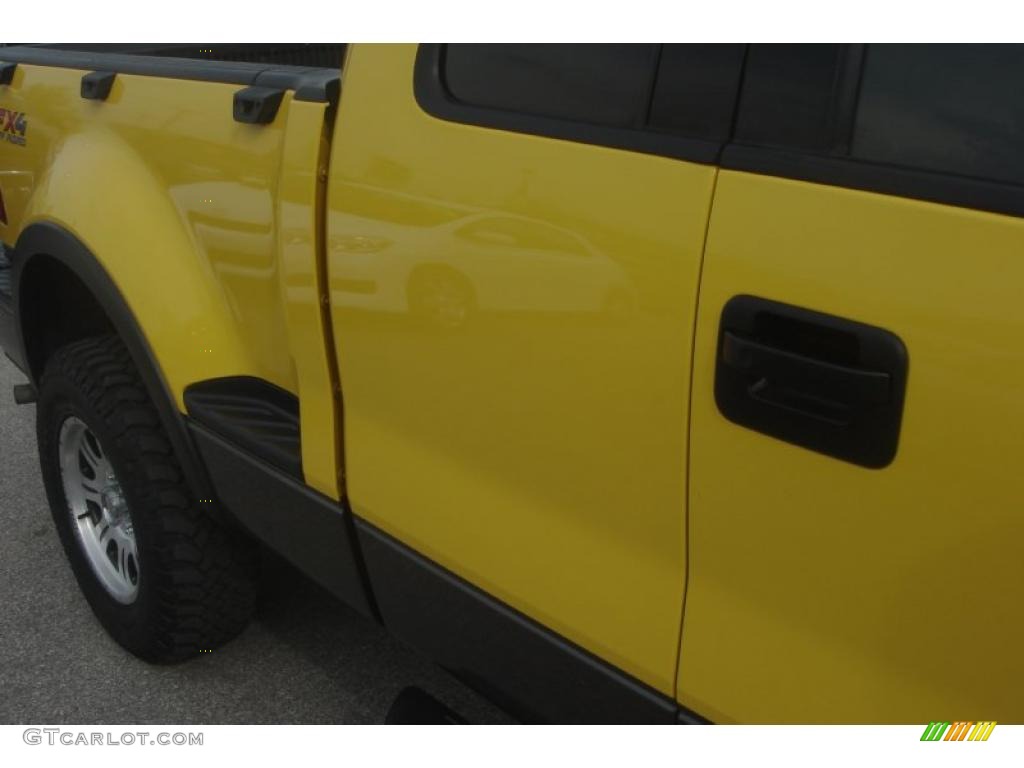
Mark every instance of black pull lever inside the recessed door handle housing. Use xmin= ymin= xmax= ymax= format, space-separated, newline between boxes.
xmin=722 ymin=331 xmax=892 ymax=425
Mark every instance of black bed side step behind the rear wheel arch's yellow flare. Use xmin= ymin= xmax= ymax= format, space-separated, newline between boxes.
xmin=184 ymin=376 xmax=302 ymax=480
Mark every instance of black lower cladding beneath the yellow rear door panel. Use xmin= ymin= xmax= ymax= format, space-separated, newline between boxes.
xmin=353 ymin=515 xmax=702 ymax=724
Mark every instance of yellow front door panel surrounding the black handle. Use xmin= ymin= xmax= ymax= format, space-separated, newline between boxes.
xmin=678 ymin=171 xmax=1024 ymax=723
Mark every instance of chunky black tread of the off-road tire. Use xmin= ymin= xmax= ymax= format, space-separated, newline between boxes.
xmin=42 ymin=336 xmax=256 ymax=663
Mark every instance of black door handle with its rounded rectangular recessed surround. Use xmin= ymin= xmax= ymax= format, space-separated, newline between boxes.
xmin=715 ymin=296 xmax=907 ymax=467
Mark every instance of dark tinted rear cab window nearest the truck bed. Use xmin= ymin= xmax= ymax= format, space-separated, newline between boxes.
xmin=444 ymin=44 xmax=657 ymax=127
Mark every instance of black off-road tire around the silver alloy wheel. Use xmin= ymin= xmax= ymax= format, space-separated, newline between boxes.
xmin=36 ymin=336 xmax=256 ymax=663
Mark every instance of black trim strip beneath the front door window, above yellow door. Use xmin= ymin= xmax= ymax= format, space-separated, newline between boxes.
xmin=721 ymin=144 xmax=1024 ymax=221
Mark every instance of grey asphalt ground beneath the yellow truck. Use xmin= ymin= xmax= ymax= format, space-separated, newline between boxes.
xmin=0 ymin=354 xmax=506 ymax=724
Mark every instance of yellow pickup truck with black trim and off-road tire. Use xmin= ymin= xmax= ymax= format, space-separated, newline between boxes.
xmin=0 ymin=44 xmax=1024 ymax=723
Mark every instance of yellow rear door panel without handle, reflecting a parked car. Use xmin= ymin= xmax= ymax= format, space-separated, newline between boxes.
xmin=328 ymin=46 xmax=715 ymax=695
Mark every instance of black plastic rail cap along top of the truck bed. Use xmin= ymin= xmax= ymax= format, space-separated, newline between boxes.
xmin=3 ymin=46 xmax=340 ymax=103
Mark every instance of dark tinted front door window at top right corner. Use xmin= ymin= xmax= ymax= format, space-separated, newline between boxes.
xmin=852 ymin=45 xmax=1024 ymax=183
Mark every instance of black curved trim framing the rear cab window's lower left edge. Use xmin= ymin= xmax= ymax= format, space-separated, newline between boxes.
xmin=414 ymin=43 xmax=722 ymax=165
